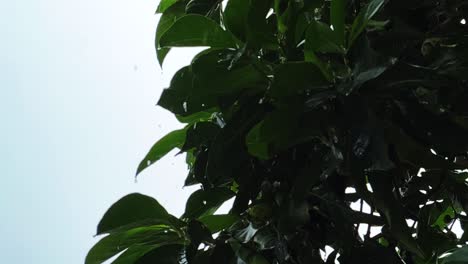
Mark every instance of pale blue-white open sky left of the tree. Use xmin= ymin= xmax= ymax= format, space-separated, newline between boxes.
xmin=0 ymin=0 xmax=194 ymax=264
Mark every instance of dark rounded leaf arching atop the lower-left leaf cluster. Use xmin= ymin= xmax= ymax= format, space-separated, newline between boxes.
xmin=97 ymin=193 xmax=173 ymax=235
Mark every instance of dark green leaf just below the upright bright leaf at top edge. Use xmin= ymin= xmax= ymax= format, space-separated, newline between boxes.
xmin=304 ymin=21 xmax=346 ymax=54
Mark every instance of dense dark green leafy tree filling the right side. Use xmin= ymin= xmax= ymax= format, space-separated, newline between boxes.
xmin=86 ymin=0 xmax=468 ymax=264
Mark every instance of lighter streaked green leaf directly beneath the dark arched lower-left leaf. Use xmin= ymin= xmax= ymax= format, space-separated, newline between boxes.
xmin=85 ymin=225 xmax=185 ymax=264
